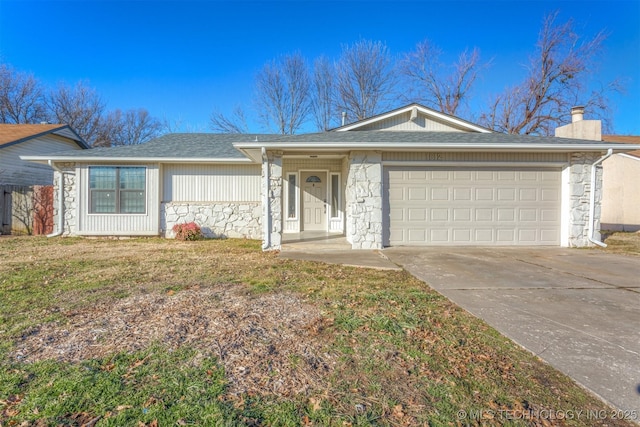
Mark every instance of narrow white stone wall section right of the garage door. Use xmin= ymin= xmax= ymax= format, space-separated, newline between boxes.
xmin=569 ymin=153 xmax=602 ymax=247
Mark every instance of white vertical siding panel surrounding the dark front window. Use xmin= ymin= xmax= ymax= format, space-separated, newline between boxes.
xmin=76 ymin=164 xmax=160 ymax=236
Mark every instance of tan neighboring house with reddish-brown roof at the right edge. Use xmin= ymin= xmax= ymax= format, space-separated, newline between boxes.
xmin=602 ymin=135 xmax=640 ymax=231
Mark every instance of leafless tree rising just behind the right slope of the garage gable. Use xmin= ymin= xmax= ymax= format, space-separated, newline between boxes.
xmin=399 ymin=40 xmax=486 ymax=115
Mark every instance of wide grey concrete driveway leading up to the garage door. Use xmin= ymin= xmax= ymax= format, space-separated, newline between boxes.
xmin=384 ymin=247 xmax=640 ymax=414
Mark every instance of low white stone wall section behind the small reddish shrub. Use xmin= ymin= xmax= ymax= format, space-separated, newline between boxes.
xmin=160 ymin=202 xmax=262 ymax=239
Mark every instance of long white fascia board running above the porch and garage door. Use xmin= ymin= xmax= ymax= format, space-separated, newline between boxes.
xmin=235 ymin=142 xmax=640 ymax=154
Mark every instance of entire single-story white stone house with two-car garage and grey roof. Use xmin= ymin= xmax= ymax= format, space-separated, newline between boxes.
xmin=23 ymin=104 xmax=640 ymax=250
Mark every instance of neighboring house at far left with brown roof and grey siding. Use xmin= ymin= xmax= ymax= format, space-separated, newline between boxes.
xmin=0 ymin=124 xmax=89 ymax=185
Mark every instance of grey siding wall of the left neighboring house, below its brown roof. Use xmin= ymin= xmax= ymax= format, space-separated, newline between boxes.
xmin=0 ymin=135 xmax=82 ymax=185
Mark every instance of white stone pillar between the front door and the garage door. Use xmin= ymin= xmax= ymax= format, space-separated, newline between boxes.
xmin=346 ymin=151 xmax=382 ymax=249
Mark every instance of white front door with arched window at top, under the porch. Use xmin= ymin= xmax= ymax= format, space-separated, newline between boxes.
xmin=301 ymin=172 xmax=327 ymax=231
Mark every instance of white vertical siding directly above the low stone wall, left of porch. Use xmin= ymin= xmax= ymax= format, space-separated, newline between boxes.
xmin=162 ymin=164 xmax=261 ymax=202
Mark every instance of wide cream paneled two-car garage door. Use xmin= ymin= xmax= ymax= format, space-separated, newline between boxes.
xmin=385 ymin=168 xmax=561 ymax=246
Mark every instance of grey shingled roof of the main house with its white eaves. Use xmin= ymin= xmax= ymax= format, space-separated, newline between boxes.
xmin=18 ymin=131 xmax=640 ymax=163
